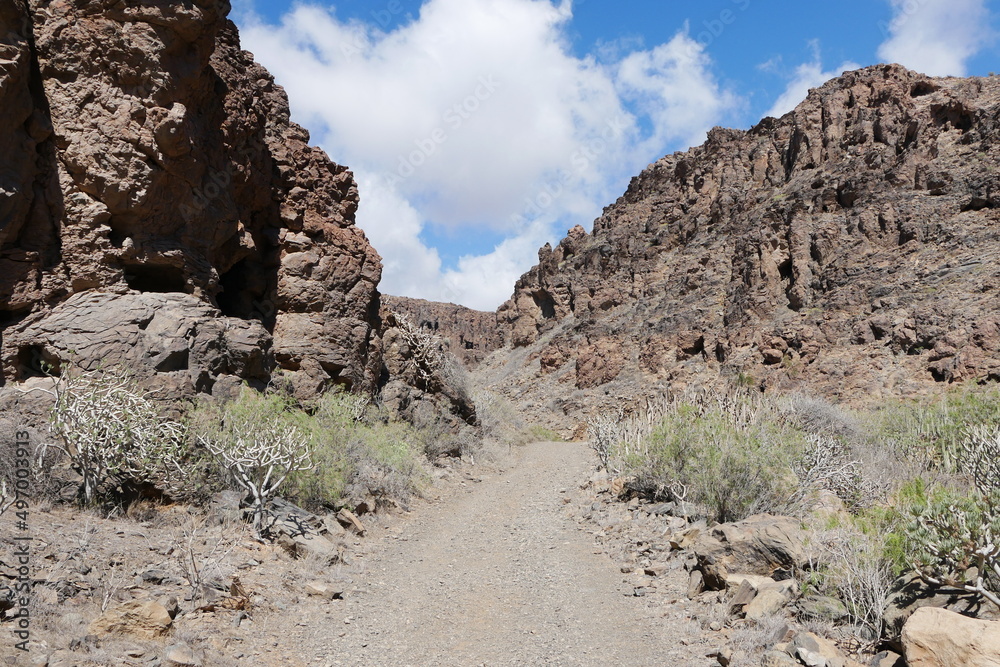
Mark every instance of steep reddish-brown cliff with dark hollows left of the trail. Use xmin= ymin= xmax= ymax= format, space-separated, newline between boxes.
xmin=0 ymin=0 xmax=381 ymax=394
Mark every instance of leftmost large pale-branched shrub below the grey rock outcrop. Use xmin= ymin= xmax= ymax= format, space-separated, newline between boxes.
xmin=38 ymin=364 xmax=185 ymax=504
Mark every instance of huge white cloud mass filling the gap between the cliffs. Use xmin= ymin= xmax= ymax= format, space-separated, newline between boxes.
xmin=234 ymin=0 xmax=735 ymax=309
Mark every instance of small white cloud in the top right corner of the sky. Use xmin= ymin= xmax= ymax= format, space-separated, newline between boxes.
xmin=878 ymin=0 xmax=992 ymax=76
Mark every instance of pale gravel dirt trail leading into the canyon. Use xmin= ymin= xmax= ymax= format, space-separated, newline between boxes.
xmin=315 ymin=443 xmax=714 ymax=667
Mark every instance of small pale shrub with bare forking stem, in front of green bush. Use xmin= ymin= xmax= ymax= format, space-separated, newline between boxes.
xmin=189 ymin=387 xmax=313 ymax=538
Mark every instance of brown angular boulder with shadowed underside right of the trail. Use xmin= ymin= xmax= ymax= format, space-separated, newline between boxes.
xmin=691 ymin=514 xmax=806 ymax=590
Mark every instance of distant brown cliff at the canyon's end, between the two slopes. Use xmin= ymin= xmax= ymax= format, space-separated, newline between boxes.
xmin=382 ymin=295 xmax=503 ymax=368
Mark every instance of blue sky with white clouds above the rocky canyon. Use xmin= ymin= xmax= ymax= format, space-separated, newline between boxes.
xmin=232 ymin=0 xmax=1000 ymax=310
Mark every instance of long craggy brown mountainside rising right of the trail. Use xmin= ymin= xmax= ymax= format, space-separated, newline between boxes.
xmin=498 ymin=65 xmax=1000 ymax=426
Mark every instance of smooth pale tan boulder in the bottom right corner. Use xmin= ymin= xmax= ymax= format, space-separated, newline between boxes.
xmin=902 ymin=607 xmax=1000 ymax=667
